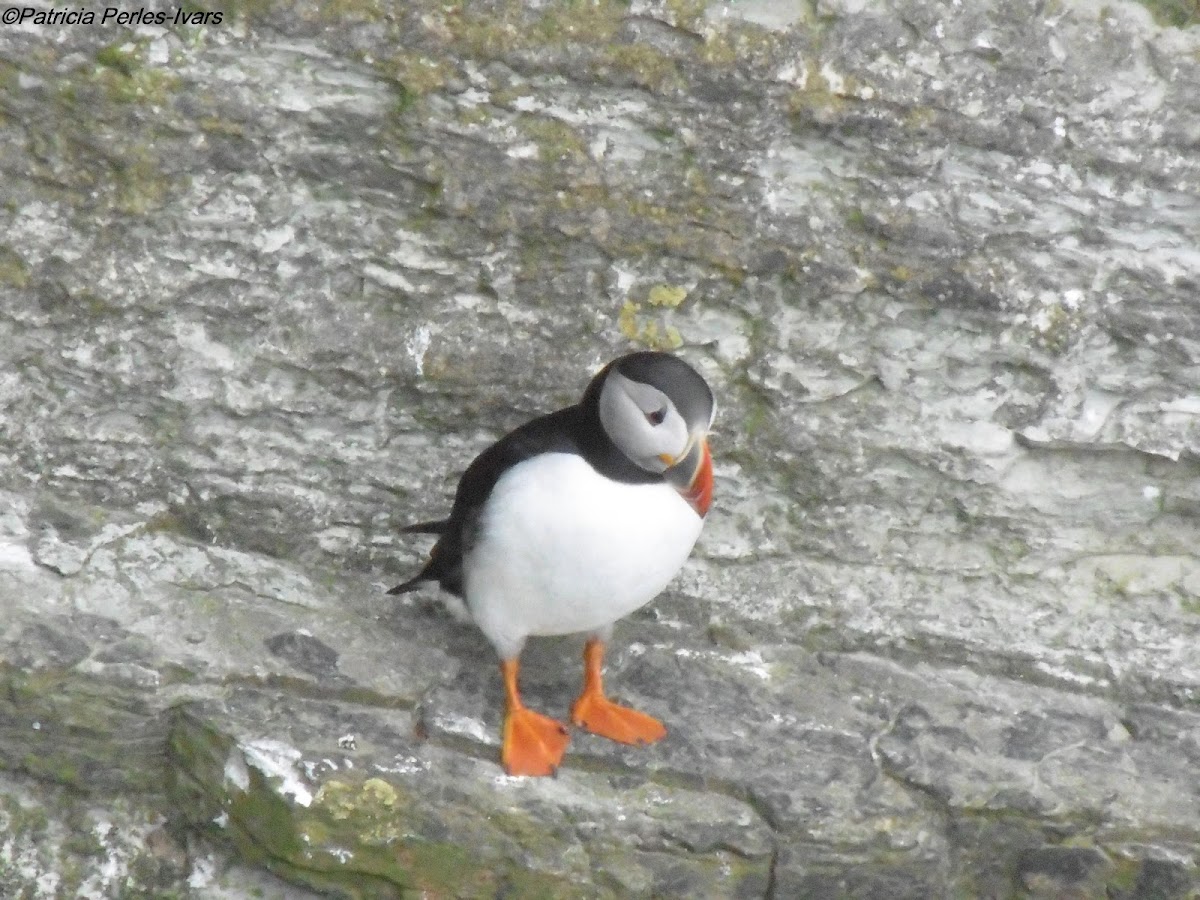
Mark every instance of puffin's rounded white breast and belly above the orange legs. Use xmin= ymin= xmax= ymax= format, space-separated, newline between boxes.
xmin=463 ymin=454 xmax=703 ymax=659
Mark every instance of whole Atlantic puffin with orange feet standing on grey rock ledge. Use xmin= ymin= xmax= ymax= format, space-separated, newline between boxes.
xmin=388 ymin=352 xmax=715 ymax=775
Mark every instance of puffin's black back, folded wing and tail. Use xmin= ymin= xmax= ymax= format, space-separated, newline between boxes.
xmin=388 ymin=407 xmax=588 ymax=596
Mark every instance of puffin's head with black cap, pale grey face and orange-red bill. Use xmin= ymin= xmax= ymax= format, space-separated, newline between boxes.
xmin=588 ymin=352 xmax=716 ymax=516
